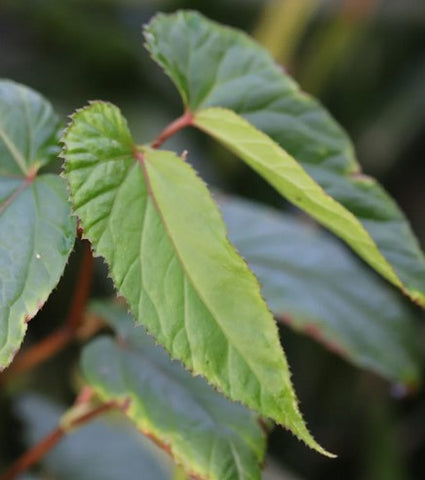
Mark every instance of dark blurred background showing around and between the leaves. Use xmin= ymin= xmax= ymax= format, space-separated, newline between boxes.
xmin=0 ymin=0 xmax=425 ymax=480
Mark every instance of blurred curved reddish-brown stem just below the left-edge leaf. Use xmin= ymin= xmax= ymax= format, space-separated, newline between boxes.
xmin=0 ymin=240 xmax=93 ymax=383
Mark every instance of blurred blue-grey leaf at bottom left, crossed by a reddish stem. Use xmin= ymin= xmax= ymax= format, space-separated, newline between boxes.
xmin=16 ymin=394 xmax=172 ymax=480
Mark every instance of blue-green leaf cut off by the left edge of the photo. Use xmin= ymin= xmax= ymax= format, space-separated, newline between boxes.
xmin=0 ymin=80 xmax=76 ymax=370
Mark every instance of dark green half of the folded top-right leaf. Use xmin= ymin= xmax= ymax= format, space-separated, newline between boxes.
xmin=145 ymin=12 xmax=425 ymax=306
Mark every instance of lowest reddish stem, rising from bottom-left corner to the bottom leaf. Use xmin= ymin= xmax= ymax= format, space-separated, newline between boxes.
xmin=0 ymin=401 xmax=122 ymax=480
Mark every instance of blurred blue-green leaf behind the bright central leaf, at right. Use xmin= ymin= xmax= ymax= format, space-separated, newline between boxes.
xmin=220 ymin=196 xmax=420 ymax=386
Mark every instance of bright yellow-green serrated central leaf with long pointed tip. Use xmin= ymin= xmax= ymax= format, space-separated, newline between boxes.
xmin=60 ymin=102 xmax=332 ymax=453
